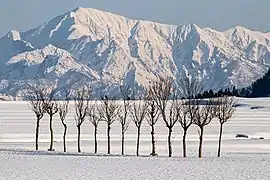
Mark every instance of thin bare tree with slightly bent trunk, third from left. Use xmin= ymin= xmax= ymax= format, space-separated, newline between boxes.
xmin=58 ymin=90 xmax=70 ymax=152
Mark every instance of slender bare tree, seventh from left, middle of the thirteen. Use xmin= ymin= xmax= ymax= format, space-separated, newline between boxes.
xmin=118 ymin=85 xmax=131 ymax=155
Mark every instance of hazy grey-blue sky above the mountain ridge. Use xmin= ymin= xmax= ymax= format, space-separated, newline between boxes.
xmin=0 ymin=0 xmax=270 ymax=36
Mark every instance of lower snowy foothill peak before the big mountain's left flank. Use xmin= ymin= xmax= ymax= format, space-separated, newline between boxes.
xmin=6 ymin=45 xmax=98 ymax=80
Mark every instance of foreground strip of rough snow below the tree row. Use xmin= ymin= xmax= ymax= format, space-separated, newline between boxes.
xmin=0 ymin=150 xmax=270 ymax=180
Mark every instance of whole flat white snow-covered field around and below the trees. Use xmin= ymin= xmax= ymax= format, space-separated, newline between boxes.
xmin=0 ymin=98 xmax=270 ymax=179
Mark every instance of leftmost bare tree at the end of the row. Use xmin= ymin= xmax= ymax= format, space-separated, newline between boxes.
xmin=28 ymin=87 xmax=45 ymax=150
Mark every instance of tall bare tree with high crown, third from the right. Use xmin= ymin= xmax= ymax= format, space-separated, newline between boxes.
xmin=179 ymin=75 xmax=202 ymax=157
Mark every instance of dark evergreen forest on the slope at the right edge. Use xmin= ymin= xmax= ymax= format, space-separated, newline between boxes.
xmin=197 ymin=69 xmax=270 ymax=98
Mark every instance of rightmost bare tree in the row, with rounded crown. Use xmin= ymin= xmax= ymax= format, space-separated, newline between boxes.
xmin=216 ymin=96 xmax=237 ymax=157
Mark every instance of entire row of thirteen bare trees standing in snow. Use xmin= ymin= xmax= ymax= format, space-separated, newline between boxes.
xmin=26 ymin=76 xmax=236 ymax=158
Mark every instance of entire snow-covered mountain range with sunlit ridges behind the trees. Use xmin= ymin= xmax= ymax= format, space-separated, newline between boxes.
xmin=0 ymin=8 xmax=270 ymax=97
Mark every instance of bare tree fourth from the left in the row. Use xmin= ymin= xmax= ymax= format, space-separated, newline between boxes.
xmin=75 ymin=87 xmax=91 ymax=153
